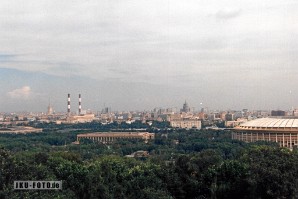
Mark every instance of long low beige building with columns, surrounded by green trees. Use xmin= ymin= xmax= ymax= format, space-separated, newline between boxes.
xmin=76 ymin=132 xmax=155 ymax=144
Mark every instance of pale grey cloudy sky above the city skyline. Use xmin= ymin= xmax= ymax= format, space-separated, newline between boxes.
xmin=0 ymin=0 xmax=298 ymax=112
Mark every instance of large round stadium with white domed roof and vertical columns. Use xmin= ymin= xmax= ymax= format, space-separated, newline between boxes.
xmin=232 ymin=118 xmax=298 ymax=149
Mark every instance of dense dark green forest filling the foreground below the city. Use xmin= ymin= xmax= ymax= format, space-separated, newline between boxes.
xmin=0 ymin=123 xmax=298 ymax=199
